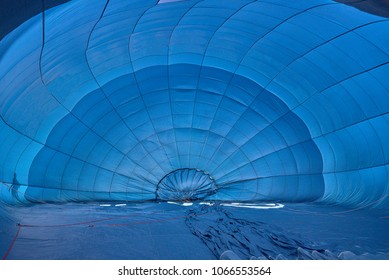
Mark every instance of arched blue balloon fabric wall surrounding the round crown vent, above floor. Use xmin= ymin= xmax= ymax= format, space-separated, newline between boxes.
xmin=0 ymin=0 xmax=389 ymax=208
